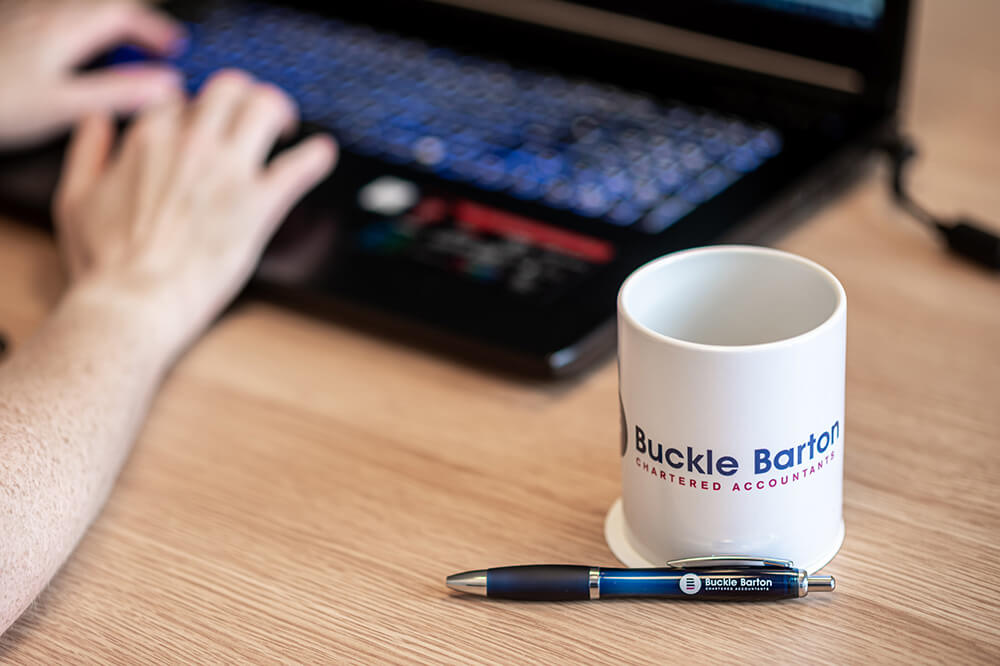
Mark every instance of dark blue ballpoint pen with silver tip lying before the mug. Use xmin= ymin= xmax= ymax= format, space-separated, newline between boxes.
xmin=447 ymin=555 xmax=836 ymax=601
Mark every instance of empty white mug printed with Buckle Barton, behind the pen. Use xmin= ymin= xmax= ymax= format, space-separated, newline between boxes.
xmin=605 ymin=246 xmax=847 ymax=573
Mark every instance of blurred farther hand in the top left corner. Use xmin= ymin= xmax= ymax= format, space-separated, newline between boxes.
xmin=0 ymin=0 xmax=183 ymax=148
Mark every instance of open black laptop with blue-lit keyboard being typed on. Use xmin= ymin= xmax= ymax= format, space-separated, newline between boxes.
xmin=0 ymin=0 xmax=909 ymax=376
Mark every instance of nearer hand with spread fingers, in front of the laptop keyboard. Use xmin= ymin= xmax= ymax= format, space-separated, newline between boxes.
xmin=54 ymin=70 xmax=337 ymax=356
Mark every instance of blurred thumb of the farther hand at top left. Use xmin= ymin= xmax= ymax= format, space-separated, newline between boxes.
xmin=56 ymin=64 xmax=181 ymax=117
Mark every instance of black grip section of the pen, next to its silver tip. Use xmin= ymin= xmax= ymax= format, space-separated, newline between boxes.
xmin=486 ymin=564 xmax=590 ymax=601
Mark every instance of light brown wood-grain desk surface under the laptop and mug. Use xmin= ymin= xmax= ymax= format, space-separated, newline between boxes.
xmin=0 ymin=0 xmax=1000 ymax=663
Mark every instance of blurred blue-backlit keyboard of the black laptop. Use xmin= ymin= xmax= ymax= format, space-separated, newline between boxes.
xmin=143 ymin=3 xmax=782 ymax=234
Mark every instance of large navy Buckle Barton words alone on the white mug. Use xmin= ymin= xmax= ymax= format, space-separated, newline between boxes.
xmin=635 ymin=421 xmax=840 ymax=476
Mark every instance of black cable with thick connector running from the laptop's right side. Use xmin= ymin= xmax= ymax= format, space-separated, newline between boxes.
xmin=881 ymin=134 xmax=1000 ymax=270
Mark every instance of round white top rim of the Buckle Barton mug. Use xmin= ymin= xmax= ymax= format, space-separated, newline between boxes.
xmin=618 ymin=244 xmax=847 ymax=353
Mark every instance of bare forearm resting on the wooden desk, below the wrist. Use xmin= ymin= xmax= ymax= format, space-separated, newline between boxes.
xmin=0 ymin=288 xmax=176 ymax=633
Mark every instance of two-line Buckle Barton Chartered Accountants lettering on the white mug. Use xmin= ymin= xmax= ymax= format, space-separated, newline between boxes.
xmin=625 ymin=421 xmax=840 ymax=493
